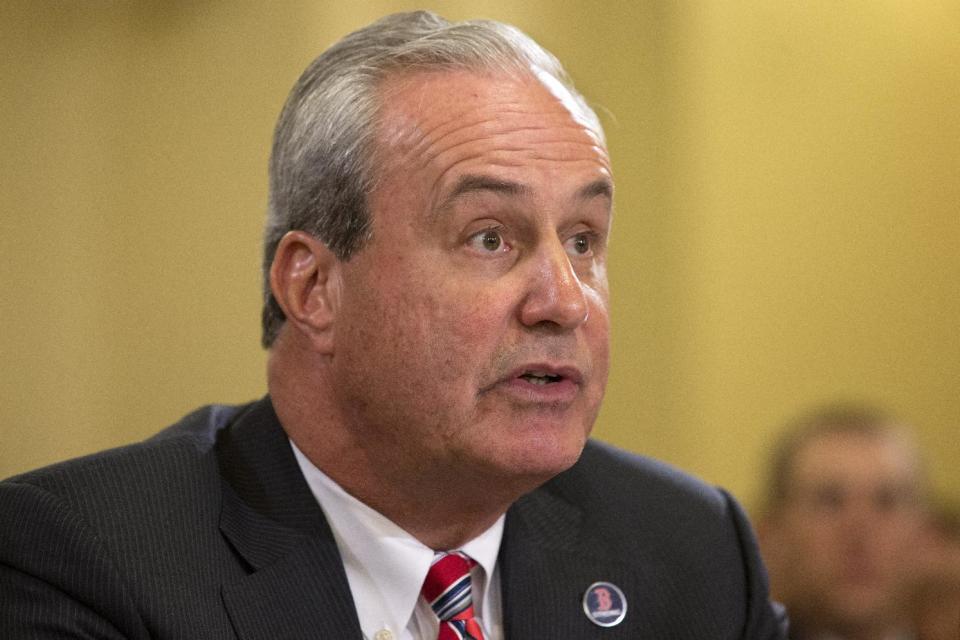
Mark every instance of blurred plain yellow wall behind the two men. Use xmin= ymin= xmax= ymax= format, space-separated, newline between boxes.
xmin=0 ymin=0 xmax=960 ymax=507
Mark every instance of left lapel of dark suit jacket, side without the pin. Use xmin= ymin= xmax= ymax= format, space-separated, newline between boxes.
xmin=217 ymin=398 xmax=362 ymax=640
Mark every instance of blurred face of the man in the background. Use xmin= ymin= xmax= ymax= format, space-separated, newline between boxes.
xmin=771 ymin=433 xmax=922 ymax=630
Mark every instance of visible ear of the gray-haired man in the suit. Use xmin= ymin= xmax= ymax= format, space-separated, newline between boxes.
xmin=270 ymin=231 xmax=340 ymax=354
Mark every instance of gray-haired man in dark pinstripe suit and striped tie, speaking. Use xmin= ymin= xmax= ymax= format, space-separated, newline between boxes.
xmin=0 ymin=13 xmax=783 ymax=640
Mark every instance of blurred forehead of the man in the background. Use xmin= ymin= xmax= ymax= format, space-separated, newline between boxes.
xmin=790 ymin=432 xmax=918 ymax=487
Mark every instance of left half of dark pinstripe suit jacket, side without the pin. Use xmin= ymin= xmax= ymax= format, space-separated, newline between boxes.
xmin=0 ymin=401 xmax=360 ymax=639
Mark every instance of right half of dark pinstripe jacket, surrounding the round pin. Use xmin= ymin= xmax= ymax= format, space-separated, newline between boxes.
xmin=499 ymin=442 xmax=786 ymax=640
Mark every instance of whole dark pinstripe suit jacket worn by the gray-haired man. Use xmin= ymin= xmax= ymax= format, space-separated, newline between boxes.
xmin=0 ymin=398 xmax=785 ymax=640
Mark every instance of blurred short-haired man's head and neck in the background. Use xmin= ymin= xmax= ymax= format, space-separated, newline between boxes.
xmin=758 ymin=406 xmax=924 ymax=640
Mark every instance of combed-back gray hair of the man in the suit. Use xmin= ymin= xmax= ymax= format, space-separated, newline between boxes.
xmin=261 ymin=11 xmax=603 ymax=348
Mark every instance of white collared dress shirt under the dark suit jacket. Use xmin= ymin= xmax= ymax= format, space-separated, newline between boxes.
xmin=290 ymin=441 xmax=504 ymax=640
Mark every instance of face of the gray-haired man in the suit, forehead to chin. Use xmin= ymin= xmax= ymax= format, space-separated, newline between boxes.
xmin=333 ymin=71 xmax=612 ymax=490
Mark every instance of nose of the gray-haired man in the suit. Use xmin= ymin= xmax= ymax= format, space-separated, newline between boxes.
xmin=520 ymin=239 xmax=589 ymax=330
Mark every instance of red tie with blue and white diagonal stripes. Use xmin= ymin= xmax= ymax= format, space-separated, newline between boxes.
xmin=420 ymin=551 xmax=483 ymax=640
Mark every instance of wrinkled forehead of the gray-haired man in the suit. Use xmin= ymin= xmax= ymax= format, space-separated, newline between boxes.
xmin=377 ymin=69 xmax=610 ymax=191
